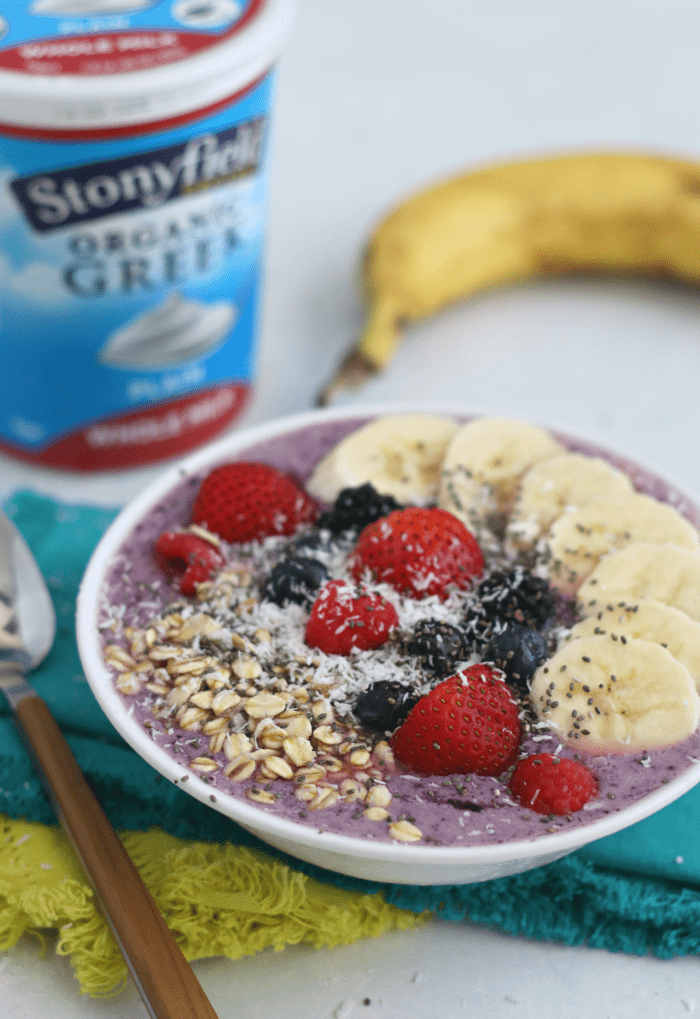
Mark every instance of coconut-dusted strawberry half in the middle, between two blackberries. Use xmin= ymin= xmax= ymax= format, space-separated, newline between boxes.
xmin=351 ymin=506 xmax=484 ymax=599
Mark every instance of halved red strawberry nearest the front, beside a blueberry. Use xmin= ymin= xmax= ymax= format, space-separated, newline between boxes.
xmin=391 ymin=664 xmax=521 ymax=775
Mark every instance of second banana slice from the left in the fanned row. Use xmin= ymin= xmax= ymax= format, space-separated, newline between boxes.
xmin=438 ymin=418 xmax=562 ymax=532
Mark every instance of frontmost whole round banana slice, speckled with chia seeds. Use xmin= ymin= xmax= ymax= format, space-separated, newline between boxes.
xmin=530 ymin=635 xmax=700 ymax=755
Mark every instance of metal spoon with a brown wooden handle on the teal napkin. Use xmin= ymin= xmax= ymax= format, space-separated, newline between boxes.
xmin=0 ymin=512 xmax=217 ymax=1019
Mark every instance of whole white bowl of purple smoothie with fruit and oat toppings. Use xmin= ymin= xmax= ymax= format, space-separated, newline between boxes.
xmin=77 ymin=407 xmax=700 ymax=884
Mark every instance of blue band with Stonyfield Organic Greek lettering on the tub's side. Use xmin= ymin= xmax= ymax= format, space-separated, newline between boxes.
xmin=0 ymin=74 xmax=271 ymax=466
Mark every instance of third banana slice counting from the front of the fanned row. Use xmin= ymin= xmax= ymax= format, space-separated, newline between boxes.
xmin=577 ymin=541 xmax=700 ymax=623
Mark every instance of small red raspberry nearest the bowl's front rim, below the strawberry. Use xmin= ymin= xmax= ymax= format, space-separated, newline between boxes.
xmin=509 ymin=754 xmax=598 ymax=814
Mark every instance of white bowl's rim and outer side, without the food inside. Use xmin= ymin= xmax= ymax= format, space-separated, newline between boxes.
xmin=77 ymin=405 xmax=700 ymax=884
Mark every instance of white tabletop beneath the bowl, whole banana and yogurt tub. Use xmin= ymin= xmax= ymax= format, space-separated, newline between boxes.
xmin=0 ymin=0 xmax=700 ymax=1019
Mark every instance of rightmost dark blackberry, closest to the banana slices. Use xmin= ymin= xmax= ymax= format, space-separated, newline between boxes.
xmin=477 ymin=567 xmax=556 ymax=630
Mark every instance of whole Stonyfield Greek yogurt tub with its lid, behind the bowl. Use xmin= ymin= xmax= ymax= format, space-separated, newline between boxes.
xmin=0 ymin=0 xmax=290 ymax=471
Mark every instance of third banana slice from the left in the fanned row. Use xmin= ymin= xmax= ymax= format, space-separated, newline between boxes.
xmin=507 ymin=452 xmax=632 ymax=548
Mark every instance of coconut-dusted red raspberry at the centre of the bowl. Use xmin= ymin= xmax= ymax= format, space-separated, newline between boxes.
xmin=306 ymin=580 xmax=398 ymax=654
